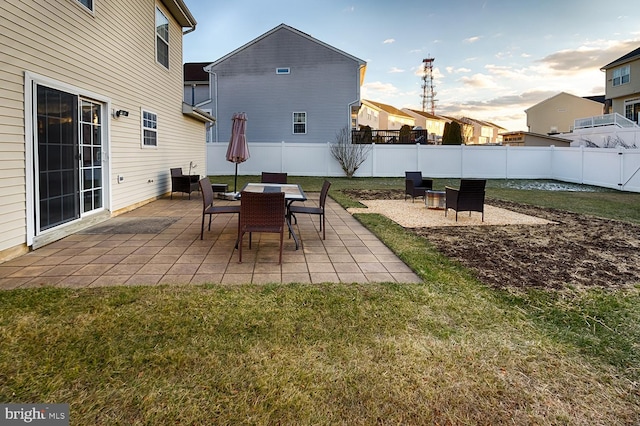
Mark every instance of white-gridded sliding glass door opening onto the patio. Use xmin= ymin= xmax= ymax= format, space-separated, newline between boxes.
xmin=34 ymin=85 xmax=104 ymax=231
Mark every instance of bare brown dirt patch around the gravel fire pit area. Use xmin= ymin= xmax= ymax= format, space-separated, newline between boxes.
xmin=345 ymin=190 xmax=640 ymax=289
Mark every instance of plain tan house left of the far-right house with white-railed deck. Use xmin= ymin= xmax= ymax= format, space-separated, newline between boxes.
xmin=525 ymin=92 xmax=604 ymax=134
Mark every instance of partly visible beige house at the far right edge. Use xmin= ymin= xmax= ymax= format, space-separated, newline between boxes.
xmin=600 ymin=47 xmax=640 ymax=124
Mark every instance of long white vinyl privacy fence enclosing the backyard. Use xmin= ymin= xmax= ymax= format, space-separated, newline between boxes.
xmin=207 ymin=142 xmax=640 ymax=192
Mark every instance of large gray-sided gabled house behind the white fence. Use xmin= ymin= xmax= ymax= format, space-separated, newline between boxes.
xmin=200 ymin=24 xmax=366 ymax=143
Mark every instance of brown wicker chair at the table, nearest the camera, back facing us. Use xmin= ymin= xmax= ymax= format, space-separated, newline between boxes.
xmin=238 ymin=191 xmax=285 ymax=264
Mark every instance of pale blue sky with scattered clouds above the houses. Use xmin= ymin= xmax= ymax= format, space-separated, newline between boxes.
xmin=183 ymin=0 xmax=640 ymax=131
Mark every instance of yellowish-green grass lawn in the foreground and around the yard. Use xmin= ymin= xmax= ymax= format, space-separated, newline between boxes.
xmin=0 ymin=176 xmax=640 ymax=425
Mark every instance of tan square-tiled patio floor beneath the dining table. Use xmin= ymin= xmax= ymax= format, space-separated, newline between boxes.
xmin=0 ymin=193 xmax=420 ymax=289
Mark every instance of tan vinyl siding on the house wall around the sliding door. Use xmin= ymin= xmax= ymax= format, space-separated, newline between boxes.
xmin=0 ymin=0 xmax=206 ymax=252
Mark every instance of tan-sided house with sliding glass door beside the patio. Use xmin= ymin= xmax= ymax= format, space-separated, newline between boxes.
xmin=0 ymin=0 xmax=213 ymax=261
